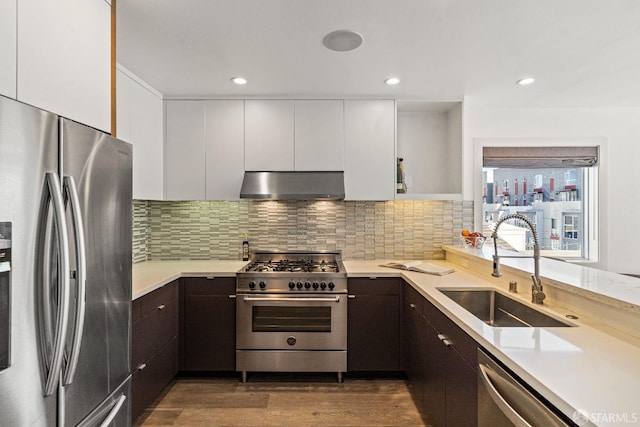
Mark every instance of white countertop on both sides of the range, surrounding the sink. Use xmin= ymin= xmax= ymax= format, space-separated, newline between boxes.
xmin=133 ymin=260 xmax=640 ymax=426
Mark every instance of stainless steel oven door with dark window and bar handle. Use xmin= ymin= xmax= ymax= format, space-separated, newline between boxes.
xmin=236 ymin=294 xmax=347 ymax=350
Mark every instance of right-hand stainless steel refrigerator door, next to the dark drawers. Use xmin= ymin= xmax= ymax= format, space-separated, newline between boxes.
xmin=60 ymin=119 xmax=132 ymax=426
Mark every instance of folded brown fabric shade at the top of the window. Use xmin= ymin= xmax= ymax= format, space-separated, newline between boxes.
xmin=482 ymin=147 xmax=598 ymax=169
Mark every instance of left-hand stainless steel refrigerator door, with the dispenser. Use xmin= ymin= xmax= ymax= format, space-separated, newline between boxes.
xmin=0 ymin=96 xmax=58 ymax=426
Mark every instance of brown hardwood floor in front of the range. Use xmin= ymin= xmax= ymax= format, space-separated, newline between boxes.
xmin=134 ymin=374 xmax=425 ymax=427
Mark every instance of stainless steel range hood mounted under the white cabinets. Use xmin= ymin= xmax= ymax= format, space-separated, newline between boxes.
xmin=240 ymin=171 xmax=344 ymax=200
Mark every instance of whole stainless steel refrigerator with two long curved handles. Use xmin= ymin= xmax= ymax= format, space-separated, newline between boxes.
xmin=0 ymin=96 xmax=132 ymax=427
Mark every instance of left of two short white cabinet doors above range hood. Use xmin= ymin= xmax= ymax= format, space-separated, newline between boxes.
xmin=244 ymin=100 xmax=294 ymax=171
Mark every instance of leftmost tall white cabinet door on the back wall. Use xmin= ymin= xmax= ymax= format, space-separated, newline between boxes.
xmin=165 ymin=101 xmax=206 ymax=200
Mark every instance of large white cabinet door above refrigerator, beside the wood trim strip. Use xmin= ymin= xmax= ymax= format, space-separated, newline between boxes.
xmin=17 ymin=0 xmax=111 ymax=133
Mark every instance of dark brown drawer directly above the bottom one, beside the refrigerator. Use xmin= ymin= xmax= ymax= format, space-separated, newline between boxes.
xmin=132 ymin=288 xmax=179 ymax=367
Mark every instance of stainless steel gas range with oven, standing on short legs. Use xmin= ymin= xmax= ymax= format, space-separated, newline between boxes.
xmin=236 ymin=251 xmax=347 ymax=382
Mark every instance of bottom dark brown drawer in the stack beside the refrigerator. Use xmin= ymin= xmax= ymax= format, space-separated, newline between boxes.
xmin=131 ymin=338 xmax=178 ymax=420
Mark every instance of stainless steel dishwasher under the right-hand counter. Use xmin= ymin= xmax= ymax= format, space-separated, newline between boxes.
xmin=478 ymin=349 xmax=577 ymax=427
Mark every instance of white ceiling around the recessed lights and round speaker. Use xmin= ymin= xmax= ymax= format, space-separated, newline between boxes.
xmin=117 ymin=0 xmax=640 ymax=107
